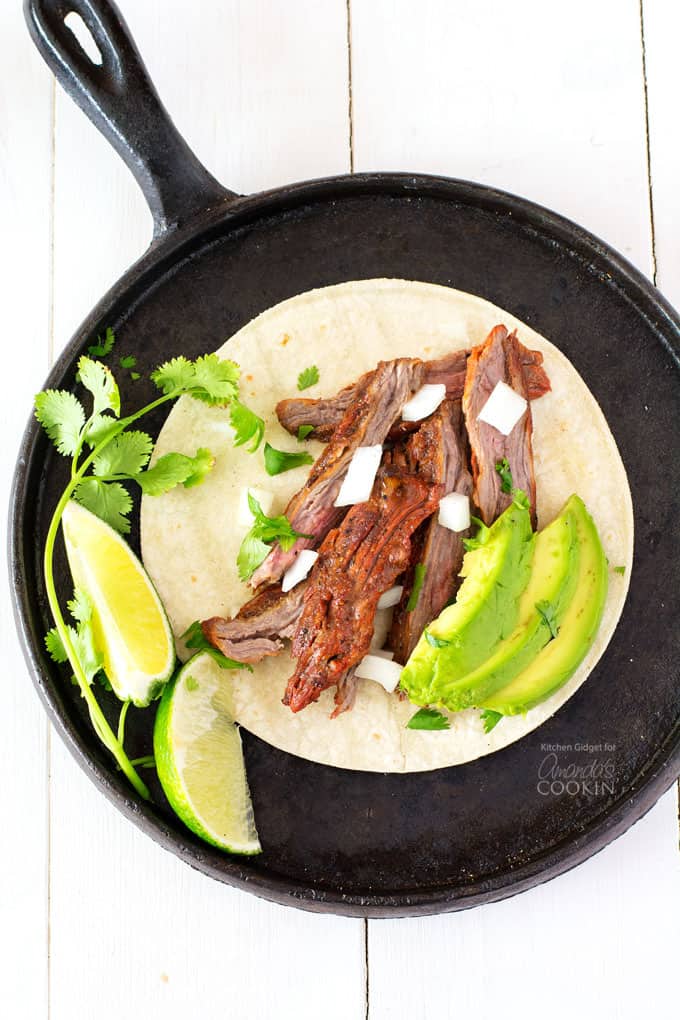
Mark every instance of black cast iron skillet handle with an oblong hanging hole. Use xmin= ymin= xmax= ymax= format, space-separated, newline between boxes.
xmin=23 ymin=0 xmax=237 ymax=239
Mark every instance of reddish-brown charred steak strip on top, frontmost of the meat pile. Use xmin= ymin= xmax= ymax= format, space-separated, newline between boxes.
xmin=283 ymin=466 xmax=441 ymax=712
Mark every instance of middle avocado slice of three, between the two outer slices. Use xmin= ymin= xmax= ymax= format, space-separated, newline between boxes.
xmin=433 ymin=500 xmax=579 ymax=712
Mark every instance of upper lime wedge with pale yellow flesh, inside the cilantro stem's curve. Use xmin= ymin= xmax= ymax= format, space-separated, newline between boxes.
xmin=62 ymin=500 xmax=175 ymax=707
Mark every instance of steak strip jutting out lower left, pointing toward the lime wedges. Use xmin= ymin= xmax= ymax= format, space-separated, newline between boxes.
xmin=201 ymin=581 xmax=308 ymax=662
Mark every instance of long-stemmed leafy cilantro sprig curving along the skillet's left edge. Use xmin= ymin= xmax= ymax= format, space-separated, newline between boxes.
xmin=35 ymin=338 xmax=260 ymax=800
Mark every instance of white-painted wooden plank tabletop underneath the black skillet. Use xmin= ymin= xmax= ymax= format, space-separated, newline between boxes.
xmin=0 ymin=0 xmax=680 ymax=1020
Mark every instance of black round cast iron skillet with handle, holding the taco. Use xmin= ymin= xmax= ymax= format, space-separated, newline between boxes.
xmin=10 ymin=0 xmax=680 ymax=917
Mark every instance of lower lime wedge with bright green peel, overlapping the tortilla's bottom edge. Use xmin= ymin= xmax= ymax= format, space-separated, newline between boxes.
xmin=154 ymin=652 xmax=262 ymax=854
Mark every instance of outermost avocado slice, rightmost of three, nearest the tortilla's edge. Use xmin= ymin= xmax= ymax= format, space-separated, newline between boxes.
xmin=480 ymin=496 xmax=608 ymax=715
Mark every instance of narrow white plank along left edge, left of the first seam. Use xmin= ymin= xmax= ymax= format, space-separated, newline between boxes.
xmin=0 ymin=4 xmax=52 ymax=1017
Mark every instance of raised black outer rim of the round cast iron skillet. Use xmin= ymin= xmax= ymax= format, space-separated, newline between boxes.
xmin=8 ymin=167 xmax=680 ymax=917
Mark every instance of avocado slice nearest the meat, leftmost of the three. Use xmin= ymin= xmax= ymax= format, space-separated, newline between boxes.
xmin=401 ymin=500 xmax=534 ymax=705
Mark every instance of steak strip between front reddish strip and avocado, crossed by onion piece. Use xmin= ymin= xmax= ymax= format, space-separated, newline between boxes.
xmin=387 ymin=400 xmax=472 ymax=664
